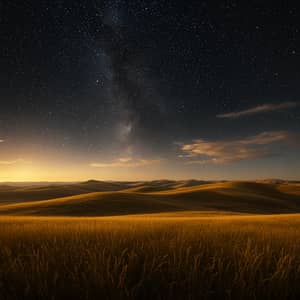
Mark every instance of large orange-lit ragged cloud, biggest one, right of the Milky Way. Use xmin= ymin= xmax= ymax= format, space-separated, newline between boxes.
xmin=181 ymin=131 xmax=294 ymax=164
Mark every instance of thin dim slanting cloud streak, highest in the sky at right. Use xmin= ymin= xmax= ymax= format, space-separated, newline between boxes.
xmin=217 ymin=102 xmax=298 ymax=119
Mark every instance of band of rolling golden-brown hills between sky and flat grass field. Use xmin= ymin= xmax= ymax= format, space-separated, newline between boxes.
xmin=0 ymin=180 xmax=300 ymax=216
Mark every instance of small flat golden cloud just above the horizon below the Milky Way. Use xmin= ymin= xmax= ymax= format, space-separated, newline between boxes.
xmin=90 ymin=157 xmax=161 ymax=168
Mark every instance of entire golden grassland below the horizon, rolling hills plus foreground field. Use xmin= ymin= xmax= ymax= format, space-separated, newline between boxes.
xmin=0 ymin=181 xmax=300 ymax=299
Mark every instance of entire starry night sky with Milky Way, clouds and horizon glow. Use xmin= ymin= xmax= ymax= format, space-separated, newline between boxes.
xmin=0 ymin=0 xmax=300 ymax=181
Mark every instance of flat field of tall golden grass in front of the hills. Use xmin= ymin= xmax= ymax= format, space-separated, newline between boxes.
xmin=0 ymin=212 xmax=300 ymax=299
